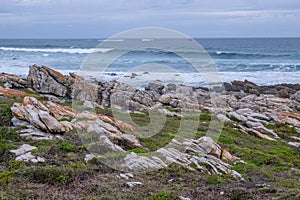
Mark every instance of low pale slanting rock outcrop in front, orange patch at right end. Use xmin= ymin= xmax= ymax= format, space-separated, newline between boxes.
xmin=117 ymin=137 xmax=242 ymax=179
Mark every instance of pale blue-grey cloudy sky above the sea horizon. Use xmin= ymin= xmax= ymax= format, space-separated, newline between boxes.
xmin=0 ymin=0 xmax=300 ymax=38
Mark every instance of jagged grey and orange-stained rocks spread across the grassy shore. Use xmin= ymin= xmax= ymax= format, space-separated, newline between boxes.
xmin=0 ymin=65 xmax=300 ymax=199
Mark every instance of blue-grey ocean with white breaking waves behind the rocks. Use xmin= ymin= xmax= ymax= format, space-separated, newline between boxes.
xmin=0 ymin=38 xmax=300 ymax=86
